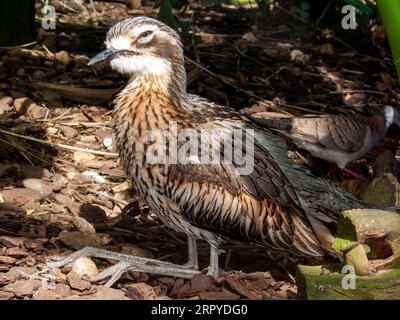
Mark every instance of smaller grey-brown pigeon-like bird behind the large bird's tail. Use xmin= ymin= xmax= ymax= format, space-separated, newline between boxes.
xmin=253 ymin=106 xmax=400 ymax=173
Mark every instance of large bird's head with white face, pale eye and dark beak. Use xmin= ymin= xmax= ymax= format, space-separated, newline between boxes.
xmin=88 ymin=17 xmax=186 ymax=92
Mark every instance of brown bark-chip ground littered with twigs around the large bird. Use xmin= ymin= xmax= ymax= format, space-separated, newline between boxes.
xmin=0 ymin=1 xmax=400 ymax=300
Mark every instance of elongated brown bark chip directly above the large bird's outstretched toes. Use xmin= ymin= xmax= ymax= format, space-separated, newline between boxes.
xmin=59 ymin=230 xmax=111 ymax=250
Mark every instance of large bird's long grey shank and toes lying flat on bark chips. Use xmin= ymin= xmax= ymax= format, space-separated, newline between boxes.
xmin=47 ymin=247 xmax=199 ymax=287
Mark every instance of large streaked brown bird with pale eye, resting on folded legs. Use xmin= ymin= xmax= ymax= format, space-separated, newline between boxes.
xmin=49 ymin=17 xmax=363 ymax=284
